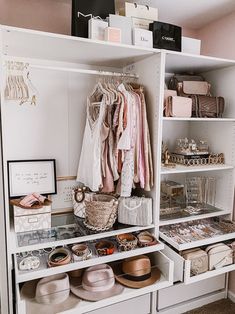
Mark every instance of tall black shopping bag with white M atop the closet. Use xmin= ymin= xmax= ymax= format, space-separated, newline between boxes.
xmin=71 ymin=0 xmax=115 ymax=38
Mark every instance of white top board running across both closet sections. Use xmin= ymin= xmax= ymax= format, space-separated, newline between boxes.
xmin=0 ymin=25 xmax=235 ymax=73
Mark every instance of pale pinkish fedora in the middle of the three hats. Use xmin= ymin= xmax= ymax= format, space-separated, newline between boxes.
xmin=71 ymin=264 xmax=124 ymax=301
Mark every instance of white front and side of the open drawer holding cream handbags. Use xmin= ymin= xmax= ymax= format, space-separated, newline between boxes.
xmin=164 ymin=246 xmax=235 ymax=284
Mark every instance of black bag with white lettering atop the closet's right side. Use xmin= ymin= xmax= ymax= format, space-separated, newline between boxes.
xmin=149 ymin=22 xmax=182 ymax=51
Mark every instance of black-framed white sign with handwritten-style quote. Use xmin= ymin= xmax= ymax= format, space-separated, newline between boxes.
xmin=7 ymin=159 xmax=57 ymax=198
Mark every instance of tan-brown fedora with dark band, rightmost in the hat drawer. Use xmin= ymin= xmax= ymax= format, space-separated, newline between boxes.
xmin=114 ymin=255 xmax=161 ymax=288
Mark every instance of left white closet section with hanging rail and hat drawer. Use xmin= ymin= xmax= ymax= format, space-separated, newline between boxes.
xmin=1 ymin=26 xmax=173 ymax=314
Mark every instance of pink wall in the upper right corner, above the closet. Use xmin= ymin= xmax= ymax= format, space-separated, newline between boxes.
xmin=198 ymin=12 xmax=235 ymax=59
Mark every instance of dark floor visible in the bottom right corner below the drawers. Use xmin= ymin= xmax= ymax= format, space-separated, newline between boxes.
xmin=185 ymin=299 xmax=235 ymax=314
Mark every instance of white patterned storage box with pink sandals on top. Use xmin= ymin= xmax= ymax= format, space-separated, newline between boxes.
xmin=13 ymin=205 xmax=51 ymax=233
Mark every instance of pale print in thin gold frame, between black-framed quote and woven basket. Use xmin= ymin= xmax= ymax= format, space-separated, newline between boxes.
xmin=50 ymin=176 xmax=78 ymax=215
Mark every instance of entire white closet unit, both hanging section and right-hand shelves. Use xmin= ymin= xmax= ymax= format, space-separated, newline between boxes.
xmin=0 ymin=26 xmax=235 ymax=314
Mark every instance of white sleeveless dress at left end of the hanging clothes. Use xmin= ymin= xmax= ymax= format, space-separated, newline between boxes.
xmin=77 ymin=96 xmax=106 ymax=192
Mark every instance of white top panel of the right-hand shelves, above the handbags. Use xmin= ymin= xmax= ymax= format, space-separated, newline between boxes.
xmin=165 ymin=50 xmax=235 ymax=73
